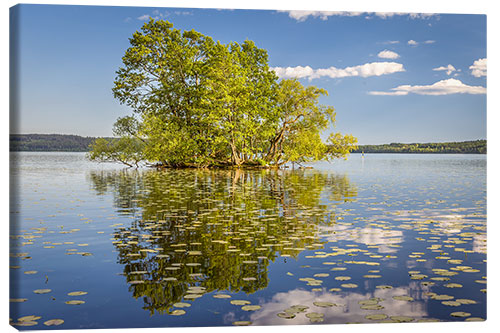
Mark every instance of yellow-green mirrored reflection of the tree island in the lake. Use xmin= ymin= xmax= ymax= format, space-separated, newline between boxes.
xmin=89 ymin=170 xmax=357 ymax=314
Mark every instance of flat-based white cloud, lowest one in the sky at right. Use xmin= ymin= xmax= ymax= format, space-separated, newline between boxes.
xmin=369 ymin=79 xmax=486 ymax=96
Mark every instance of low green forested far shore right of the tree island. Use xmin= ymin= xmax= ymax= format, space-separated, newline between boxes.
xmin=352 ymin=140 xmax=486 ymax=154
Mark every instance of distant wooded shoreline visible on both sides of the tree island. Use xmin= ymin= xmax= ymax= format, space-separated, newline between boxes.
xmin=9 ymin=134 xmax=486 ymax=154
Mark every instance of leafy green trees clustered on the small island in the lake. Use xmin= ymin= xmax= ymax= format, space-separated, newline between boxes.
xmin=90 ymin=19 xmax=353 ymax=167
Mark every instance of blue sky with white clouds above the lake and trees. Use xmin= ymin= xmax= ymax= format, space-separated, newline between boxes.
xmin=9 ymin=5 xmax=487 ymax=144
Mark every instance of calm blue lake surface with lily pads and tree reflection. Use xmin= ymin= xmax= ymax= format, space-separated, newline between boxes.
xmin=10 ymin=153 xmax=486 ymax=329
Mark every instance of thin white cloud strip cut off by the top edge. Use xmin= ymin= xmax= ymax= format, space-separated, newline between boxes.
xmin=278 ymin=10 xmax=437 ymax=22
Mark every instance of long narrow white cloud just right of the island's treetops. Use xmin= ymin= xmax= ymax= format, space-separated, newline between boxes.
xmin=271 ymin=62 xmax=405 ymax=80
